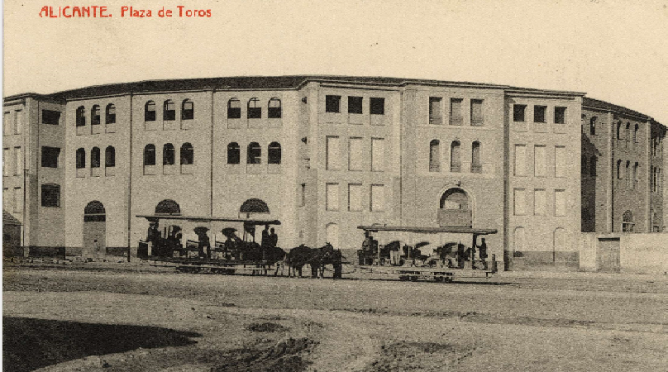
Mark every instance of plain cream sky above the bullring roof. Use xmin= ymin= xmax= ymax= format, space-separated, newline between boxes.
xmin=3 ymin=0 xmax=668 ymax=124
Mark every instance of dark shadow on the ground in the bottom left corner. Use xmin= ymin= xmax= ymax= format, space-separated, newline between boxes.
xmin=2 ymin=317 xmax=201 ymax=372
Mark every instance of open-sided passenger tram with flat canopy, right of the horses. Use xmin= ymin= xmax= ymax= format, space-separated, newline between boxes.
xmin=357 ymin=225 xmax=497 ymax=282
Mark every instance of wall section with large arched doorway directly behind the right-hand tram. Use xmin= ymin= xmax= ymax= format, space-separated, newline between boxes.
xmin=402 ymin=87 xmax=504 ymax=259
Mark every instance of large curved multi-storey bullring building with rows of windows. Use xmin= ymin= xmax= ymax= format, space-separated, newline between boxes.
xmin=3 ymin=76 xmax=665 ymax=263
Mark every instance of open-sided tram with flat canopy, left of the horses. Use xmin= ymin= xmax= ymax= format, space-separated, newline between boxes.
xmin=137 ymin=214 xmax=285 ymax=275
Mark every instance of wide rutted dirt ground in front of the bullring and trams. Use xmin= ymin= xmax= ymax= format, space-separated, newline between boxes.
xmin=3 ymin=264 xmax=668 ymax=372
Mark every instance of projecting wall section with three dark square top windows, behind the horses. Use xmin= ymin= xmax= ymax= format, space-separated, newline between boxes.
xmin=308 ymin=85 xmax=401 ymax=249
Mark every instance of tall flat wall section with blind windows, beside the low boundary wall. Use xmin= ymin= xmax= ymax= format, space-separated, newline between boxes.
xmin=505 ymin=94 xmax=582 ymax=268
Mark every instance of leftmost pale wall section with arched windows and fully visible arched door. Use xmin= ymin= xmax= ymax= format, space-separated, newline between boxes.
xmin=64 ymin=95 xmax=131 ymax=254
